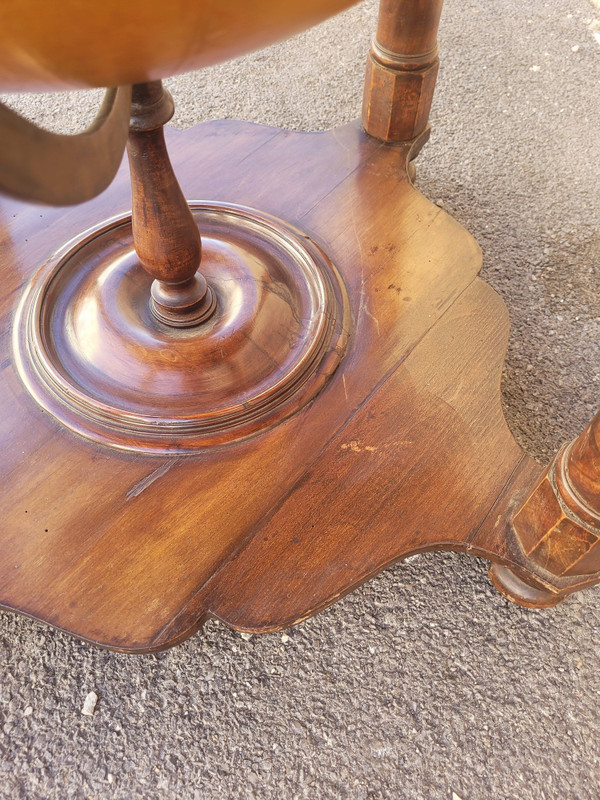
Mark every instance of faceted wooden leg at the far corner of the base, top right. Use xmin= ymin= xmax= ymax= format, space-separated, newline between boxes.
xmin=363 ymin=0 xmax=442 ymax=142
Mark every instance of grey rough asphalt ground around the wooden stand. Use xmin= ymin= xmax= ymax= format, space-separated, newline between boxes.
xmin=0 ymin=0 xmax=600 ymax=800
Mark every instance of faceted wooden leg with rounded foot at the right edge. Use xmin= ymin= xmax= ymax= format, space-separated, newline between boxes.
xmin=490 ymin=412 xmax=600 ymax=607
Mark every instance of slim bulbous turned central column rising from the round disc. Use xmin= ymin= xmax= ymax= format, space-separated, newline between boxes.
xmin=127 ymin=81 xmax=216 ymax=327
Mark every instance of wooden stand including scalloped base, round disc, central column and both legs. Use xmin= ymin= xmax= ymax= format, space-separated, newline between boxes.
xmin=0 ymin=0 xmax=600 ymax=652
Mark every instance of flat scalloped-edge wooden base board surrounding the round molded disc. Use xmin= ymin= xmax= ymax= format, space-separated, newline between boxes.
xmin=0 ymin=121 xmax=596 ymax=652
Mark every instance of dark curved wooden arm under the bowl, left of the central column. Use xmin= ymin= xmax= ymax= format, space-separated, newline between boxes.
xmin=0 ymin=86 xmax=131 ymax=206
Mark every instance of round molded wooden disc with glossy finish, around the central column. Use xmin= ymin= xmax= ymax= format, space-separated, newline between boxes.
xmin=14 ymin=203 xmax=350 ymax=454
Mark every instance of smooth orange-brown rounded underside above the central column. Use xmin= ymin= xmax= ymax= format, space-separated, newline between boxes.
xmin=0 ymin=0 xmax=352 ymax=91
